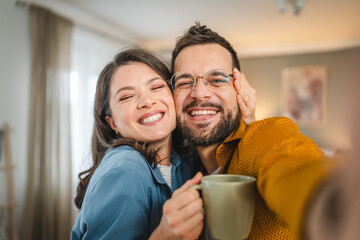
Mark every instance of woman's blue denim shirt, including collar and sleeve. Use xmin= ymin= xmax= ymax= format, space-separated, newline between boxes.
xmin=71 ymin=146 xmax=200 ymax=240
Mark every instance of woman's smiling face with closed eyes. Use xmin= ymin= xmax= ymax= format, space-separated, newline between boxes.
xmin=106 ymin=62 xmax=176 ymax=142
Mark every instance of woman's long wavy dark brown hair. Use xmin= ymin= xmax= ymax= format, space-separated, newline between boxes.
xmin=74 ymin=48 xmax=170 ymax=209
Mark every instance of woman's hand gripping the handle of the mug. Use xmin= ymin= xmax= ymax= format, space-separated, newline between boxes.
xmin=149 ymin=173 xmax=204 ymax=240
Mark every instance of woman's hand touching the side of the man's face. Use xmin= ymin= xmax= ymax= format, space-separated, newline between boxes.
xmin=233 ymin=68 xmax=256 ymax=125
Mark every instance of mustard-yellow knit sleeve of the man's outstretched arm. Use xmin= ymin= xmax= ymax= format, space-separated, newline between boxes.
xmin=255 ymin=118 xmax=330 ymax=238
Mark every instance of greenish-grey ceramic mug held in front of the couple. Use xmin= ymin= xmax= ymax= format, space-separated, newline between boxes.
xmin=191 ymin=174 xmax=257 ymax=240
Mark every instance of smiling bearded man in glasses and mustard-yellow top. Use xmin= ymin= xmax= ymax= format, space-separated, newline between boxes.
xmin=171 ymin=23 xmax=332 ymax=239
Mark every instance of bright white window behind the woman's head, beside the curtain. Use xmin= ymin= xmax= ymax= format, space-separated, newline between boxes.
xmin=70 ymin=26 xmax=126 ymax=202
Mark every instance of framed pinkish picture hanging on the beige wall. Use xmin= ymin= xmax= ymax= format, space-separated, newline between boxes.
xmin=281 ymin=66 xmax=327 ymax=126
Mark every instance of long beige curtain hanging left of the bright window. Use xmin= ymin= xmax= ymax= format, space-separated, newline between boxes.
xmin=22 ymin=6 xmax=72 ymax=240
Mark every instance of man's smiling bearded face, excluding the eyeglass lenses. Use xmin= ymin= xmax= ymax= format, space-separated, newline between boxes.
xmin=173 ymin=43 xmax=240 ymax=146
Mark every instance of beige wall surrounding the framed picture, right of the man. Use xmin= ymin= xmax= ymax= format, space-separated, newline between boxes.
xmin=240 ymin=48 xmax=360 ymax=149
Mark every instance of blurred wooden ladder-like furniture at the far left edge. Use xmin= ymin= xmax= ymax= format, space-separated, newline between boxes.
xmin=0 ymin=124 xmax=19 ymax=240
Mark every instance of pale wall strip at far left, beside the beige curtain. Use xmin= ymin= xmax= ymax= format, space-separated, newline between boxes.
xmin=0 ymin=0 xmax=30 ymax=232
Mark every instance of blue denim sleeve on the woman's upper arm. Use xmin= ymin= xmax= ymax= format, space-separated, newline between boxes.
xmin=72 ymin=162 xmax=150 ymax=240
